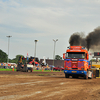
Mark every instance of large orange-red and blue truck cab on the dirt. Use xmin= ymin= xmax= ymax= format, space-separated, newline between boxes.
xmin=63 ymin=46 xmax=93 ymax=79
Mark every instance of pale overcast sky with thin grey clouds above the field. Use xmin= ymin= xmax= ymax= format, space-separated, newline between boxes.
xmin=0 ymin=0 xmax=100 ymax=59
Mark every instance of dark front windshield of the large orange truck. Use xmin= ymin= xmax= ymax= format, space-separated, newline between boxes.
xmin=66 ymin=52 xmax=85 ymax=59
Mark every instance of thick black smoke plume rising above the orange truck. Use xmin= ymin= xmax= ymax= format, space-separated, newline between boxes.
xmin=69 ymin=27 xmax=100 ymax=51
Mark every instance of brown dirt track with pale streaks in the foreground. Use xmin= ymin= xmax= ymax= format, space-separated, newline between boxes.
xmin=0 ymin=72 xmax=100 ymax=100
